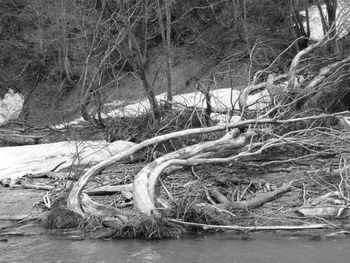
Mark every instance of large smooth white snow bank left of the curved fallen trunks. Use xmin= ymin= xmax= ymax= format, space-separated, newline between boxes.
xmin=0 ymin=141 xmax=135 ymax=186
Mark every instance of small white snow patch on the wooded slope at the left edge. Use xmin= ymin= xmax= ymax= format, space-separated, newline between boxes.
xmin=0 ymin=89 xmax=24 ymax=124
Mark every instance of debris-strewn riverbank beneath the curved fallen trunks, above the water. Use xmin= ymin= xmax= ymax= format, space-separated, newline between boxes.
xmin=0 ymin=128 xmax=349 ymax=239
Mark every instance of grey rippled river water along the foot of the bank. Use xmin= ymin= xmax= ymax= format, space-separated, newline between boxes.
xmin=0 ymin=233 xmax=350 ymax=263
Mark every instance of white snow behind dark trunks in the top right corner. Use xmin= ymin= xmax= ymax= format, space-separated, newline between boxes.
xmin=300 ymin=0 xmax=350 ymax=41
